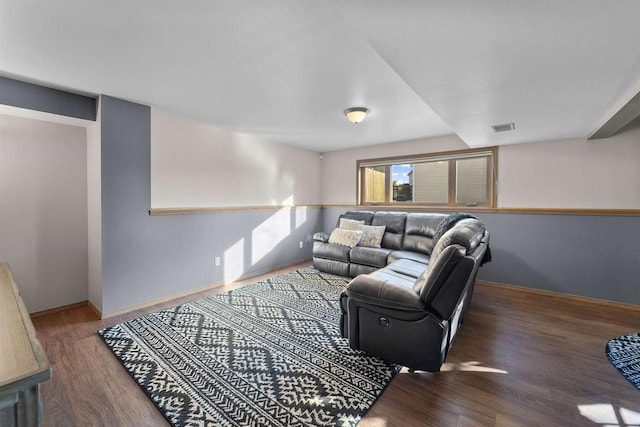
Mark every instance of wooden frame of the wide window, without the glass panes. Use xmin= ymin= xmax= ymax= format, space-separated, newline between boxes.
xmin=356 ymin=147 xmax=498 ymax=209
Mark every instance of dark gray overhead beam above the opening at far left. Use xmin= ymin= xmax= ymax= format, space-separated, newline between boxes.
xmin=0 ymin=76 xmax=96 ymax=120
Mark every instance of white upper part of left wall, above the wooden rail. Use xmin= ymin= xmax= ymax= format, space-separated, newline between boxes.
xmin=151 ymin=110 xmax=321 ymax=208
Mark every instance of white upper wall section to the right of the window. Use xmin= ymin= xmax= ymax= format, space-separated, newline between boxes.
xmin=498 ymin=123 xmax=640 ymax=209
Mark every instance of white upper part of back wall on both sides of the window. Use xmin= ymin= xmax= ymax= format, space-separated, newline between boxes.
xmin=322 ymin=126 xmax=640 ymax=209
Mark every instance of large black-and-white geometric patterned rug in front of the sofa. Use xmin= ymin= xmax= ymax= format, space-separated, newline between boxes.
xmin=98 ymin=268 xmax=398 ymax=426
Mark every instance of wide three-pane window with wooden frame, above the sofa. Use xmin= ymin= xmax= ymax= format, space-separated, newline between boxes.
xmin=357 ymin=148 xmax=497 ymax=207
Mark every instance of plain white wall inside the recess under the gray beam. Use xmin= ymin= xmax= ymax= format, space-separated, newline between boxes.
xmin=0 ymin=115 xmax=87 ymax=312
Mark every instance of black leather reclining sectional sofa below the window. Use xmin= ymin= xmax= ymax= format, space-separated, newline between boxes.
xmin=313 ymin=211 xmax=490 ymax=372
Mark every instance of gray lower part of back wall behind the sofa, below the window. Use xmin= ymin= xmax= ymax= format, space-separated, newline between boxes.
xmin=323 ymin=208 xmax=640 ymax=305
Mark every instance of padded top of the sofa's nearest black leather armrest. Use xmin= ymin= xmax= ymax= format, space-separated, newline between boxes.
xmin=346 ymin=270 xmax=425 ymax=312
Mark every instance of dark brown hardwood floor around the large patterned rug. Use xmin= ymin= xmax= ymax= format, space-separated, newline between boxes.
xmin=33 ymin=266 xmax=640 ymax=427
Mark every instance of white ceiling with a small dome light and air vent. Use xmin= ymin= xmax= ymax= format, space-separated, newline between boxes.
xmin=0 ymin=0 xmax=640 ymax=152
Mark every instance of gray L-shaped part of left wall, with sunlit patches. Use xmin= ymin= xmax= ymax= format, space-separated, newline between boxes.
xmin=101 ymin=96 xmax=322 ymax=315
